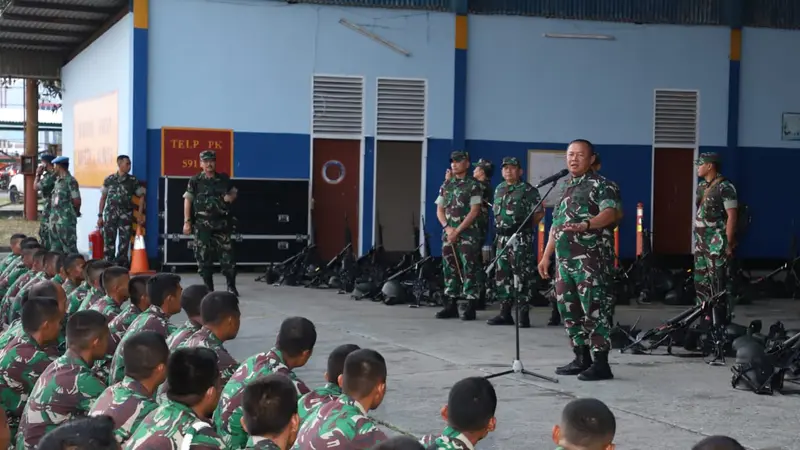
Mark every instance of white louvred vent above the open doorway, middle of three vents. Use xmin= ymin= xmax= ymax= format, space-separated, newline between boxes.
xmin=375 ymin=78 xmax=426 ymax=138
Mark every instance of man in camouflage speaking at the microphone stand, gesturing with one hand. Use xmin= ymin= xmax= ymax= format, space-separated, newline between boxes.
xmin=539 ymin=139 xmax=617 ymax=381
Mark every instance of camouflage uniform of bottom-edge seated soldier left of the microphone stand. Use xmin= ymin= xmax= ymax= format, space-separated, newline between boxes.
xmin=292 ymin=394 xmax=389 ymax=450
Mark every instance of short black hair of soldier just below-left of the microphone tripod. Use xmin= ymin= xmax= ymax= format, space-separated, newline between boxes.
xmin=447 ymin=377 xmax=497 ymax=433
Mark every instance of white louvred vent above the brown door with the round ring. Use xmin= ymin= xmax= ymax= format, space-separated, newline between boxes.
xmin=312 ymin=75 xmax=364 ymax=136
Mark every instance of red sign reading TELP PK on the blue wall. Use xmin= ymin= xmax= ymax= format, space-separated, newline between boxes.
xmin=161 ymin=127 xmax=233 ymax=178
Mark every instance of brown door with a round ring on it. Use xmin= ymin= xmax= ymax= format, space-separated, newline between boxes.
xmin=311 ymin=139 xmax=361 ymax=260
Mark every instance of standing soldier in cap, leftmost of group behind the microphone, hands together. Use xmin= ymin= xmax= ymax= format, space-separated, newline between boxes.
xmin=436 ymin=151 xmax=483 ymax=320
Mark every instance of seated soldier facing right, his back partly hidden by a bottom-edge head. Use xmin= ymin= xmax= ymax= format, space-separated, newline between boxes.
xmin=216 ymin=316 xmax=317 ymax=448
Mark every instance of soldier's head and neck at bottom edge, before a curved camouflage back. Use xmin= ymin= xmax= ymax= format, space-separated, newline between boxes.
xmin=242 ymin=374 xmax=300 ymax=450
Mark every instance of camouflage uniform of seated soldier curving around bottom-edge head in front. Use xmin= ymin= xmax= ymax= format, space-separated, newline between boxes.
xmin=214 ymin=348 xmax=309 ymax=449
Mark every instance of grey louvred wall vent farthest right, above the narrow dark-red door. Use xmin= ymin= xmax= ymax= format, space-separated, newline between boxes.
xmin=653 ymin=90 xmax=698 ymax=146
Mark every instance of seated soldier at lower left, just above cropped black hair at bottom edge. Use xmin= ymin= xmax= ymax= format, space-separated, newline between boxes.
xmin=17 ymin=311 xmax=109 ymax=450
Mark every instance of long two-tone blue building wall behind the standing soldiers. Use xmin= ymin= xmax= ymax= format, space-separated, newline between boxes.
xmin=64 ymin=0 xmax=800 ymax=258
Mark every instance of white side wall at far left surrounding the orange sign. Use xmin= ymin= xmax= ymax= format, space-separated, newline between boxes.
xmin=61 ymin=14 xmax=136 ymax=252
